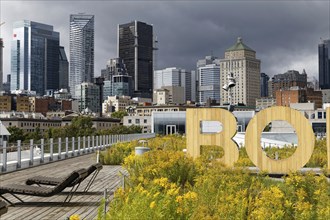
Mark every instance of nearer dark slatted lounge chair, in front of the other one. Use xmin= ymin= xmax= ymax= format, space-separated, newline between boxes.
xmin=0 ymin=169 xmax=87 ymax=205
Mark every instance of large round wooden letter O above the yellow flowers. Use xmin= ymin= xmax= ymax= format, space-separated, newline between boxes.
xmin=245 ymin=106 xmax=315 ymax=174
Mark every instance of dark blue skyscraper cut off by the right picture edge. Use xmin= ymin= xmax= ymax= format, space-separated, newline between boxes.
xmin=319 ymin=39 xmax=330 ymax=89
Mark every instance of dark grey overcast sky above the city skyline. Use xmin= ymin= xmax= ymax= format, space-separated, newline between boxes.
xmin=0 ymin=0 xmax=330 ymax=81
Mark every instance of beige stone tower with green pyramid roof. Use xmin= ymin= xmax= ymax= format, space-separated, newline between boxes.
xmin=220 ymin=37 xmax=260 ymax=107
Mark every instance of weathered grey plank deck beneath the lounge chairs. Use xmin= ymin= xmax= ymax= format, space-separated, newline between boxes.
xmin=0 ymin=154 xmax=123 ymax=220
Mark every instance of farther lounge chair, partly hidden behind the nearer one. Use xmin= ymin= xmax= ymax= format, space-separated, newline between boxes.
xmin=25 ymin=163 xmax=103 ymax=192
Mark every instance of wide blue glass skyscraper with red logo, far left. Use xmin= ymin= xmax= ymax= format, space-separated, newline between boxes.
xmin=10 ymin=20 xmax=60 ymax=95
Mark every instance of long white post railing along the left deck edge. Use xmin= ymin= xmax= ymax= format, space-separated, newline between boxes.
xmin=0 ymin=133 xmax=155 ymax=173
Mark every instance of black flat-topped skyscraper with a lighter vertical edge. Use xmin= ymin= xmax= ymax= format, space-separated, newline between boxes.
xmin=118 ymin=21 xmax=154 ymax=98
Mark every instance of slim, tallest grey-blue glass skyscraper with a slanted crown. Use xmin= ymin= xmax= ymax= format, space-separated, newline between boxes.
xmin=69 ymin=14 xmax=94 ymax=96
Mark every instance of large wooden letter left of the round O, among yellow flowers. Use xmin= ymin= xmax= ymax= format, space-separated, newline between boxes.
xmin=186 ymin=108 xmax=239 ymax=166
